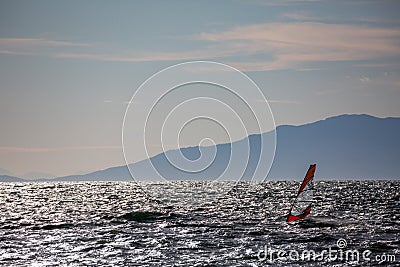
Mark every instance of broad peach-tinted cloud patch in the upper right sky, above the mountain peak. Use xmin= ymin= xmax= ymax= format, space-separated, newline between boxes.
xmin=194 ymin=22 xmax=400 ymax=70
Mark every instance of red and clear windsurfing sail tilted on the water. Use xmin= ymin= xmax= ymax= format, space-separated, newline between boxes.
xmin=287 ymin=164 xmax=316 ymax=222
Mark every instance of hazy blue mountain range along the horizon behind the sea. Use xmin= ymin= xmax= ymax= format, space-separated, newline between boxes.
xmin=0 ymin=115 xmax=400 ymax=182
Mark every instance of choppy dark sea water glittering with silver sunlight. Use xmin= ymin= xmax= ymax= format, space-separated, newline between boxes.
xmin=0 ymin=181 xmax=400 ymax=266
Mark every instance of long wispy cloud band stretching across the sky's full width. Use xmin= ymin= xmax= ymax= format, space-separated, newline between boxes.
xmin=0 ymin=22 xmax=400 ymax=71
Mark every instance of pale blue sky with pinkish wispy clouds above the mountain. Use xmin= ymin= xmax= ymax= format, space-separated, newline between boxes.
xmin=0 ymin=0 xmax=400 ymax=178
